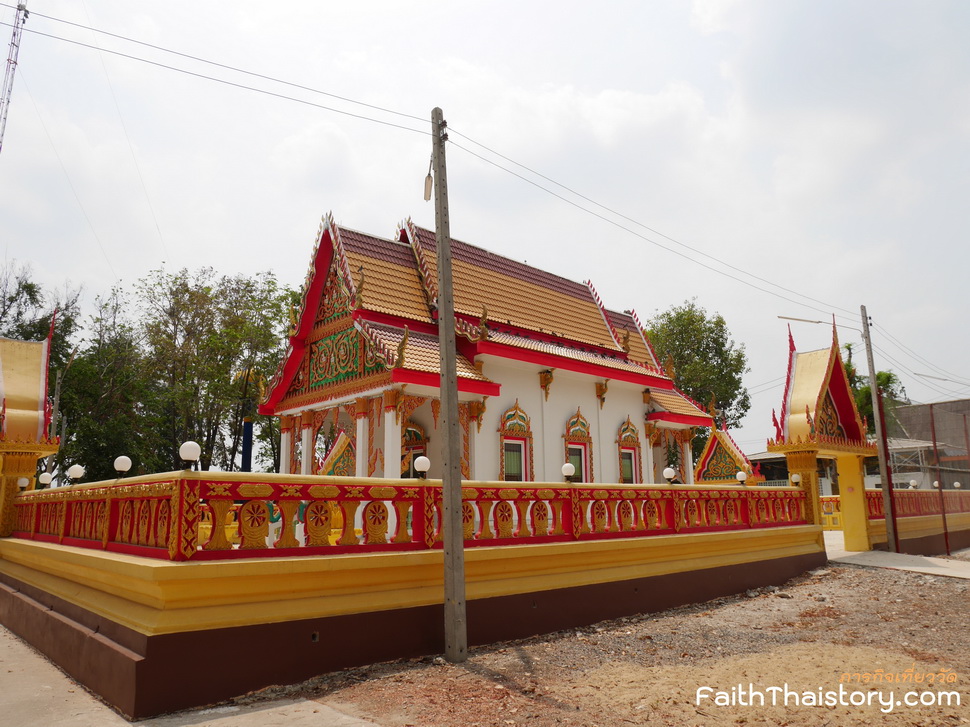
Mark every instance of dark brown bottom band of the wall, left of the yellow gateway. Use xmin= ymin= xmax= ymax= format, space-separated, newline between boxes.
xmin=0 ymin=553 xmax=826 ymax=719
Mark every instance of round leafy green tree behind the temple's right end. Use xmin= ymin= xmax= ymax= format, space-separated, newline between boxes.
xmin=647 ymin=299 xmax=751 ymax=458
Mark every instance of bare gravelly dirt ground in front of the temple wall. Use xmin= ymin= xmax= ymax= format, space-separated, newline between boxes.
xmin=236 ymin=555 xmax=970 ymax=727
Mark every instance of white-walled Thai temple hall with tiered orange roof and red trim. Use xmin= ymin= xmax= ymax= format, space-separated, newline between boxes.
xmin=260 ymin=215 xmax=711 ymax=483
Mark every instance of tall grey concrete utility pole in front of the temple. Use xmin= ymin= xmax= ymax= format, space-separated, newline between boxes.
xmin=431 ymin=108 xmax=468 ymax=662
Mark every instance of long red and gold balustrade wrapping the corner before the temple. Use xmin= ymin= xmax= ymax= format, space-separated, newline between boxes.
xmin=13 ymin=472 xmax=806 ymax=560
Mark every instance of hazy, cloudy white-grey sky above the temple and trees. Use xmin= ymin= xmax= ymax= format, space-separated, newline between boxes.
xmin=0 ymin=0 xmax=970 ymax=452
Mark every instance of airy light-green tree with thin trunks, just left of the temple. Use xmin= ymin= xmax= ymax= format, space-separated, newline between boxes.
xmin=138 ymin=268 xmax=292 ymax=469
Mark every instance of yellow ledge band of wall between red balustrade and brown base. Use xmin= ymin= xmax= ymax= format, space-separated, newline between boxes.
xmin=0 ymin=525 xmax=822 ymax=635
